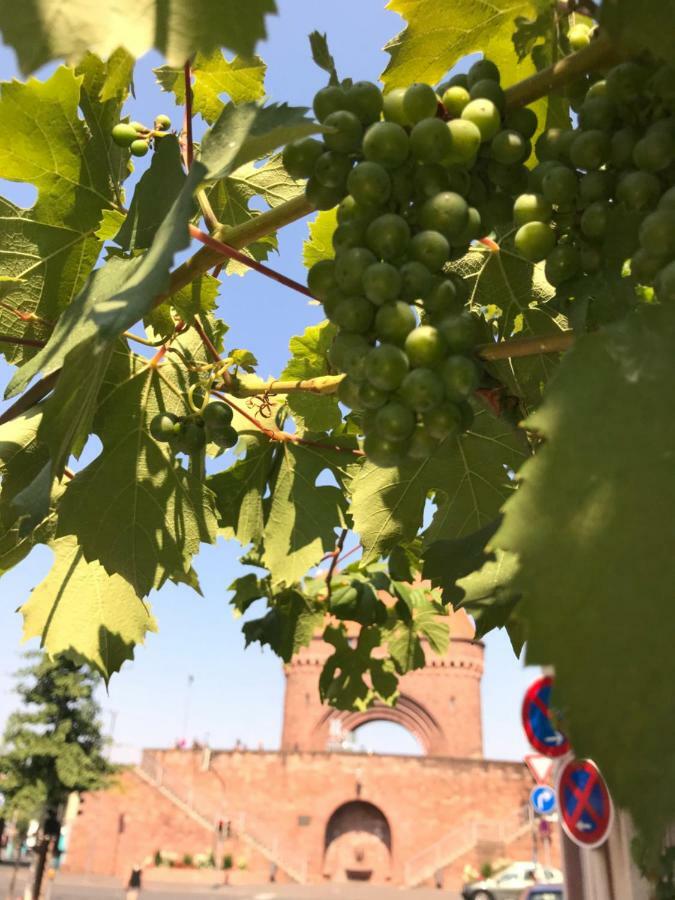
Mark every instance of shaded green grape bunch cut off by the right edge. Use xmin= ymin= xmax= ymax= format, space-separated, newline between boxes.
xmin=513 ymin=60 xmax=675 ymax=301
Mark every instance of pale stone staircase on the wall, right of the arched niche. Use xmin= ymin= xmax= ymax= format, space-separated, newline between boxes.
xmin=404 ymin=806 xmax=530 ymax=887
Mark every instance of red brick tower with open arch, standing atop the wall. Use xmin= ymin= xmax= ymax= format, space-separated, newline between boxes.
xmin=281 ymin=611 xmax=484 ymax=759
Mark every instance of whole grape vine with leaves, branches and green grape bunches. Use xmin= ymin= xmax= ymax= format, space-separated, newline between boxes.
xmin=0 ymin=0 xmax=675 ymax=868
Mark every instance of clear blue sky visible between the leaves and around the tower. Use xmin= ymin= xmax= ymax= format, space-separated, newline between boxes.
xmin=0 ymin=0 xmax=535 ymax=759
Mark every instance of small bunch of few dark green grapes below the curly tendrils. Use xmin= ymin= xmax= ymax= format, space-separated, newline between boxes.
xmin=150 ymin=400 xmax=239 ymax=455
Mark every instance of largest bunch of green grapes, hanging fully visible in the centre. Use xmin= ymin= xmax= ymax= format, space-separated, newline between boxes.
xmin=283 ymin=59 xmax=537 ymax=466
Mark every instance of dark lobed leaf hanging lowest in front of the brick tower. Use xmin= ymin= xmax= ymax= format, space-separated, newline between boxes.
xmin=319 ymin=625 xmax=398 ymax=710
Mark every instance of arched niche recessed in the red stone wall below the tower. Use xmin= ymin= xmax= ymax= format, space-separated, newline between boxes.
xmin=323 ymin=800 xmax=391 ymax=884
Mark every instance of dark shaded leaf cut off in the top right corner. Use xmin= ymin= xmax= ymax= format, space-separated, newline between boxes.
xmin=600 ymin=0 xmax=675 ymax=62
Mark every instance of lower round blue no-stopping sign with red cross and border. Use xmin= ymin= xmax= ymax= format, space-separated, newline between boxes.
xmin=556 ymin=759 xmax=614 ymax=848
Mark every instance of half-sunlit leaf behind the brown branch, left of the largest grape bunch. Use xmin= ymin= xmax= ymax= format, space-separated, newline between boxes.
xmin=209 ymin=155 xmax=305 ymax=275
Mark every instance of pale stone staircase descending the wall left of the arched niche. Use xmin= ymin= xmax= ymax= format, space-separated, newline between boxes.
xmin=135 ymin=756 xmax=307 ymax=884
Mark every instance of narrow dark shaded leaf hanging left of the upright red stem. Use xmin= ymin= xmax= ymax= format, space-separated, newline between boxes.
xmin=114 ymin=135 xmax=186 ymax=252
